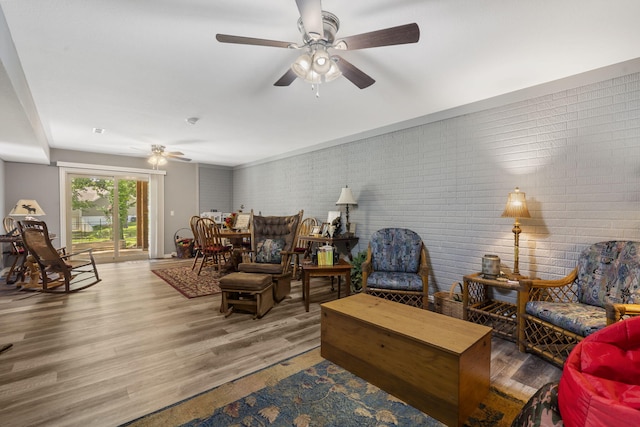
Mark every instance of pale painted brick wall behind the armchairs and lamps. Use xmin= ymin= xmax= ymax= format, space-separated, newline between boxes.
xmin=234 ymin=68 xmax=640 ymax=292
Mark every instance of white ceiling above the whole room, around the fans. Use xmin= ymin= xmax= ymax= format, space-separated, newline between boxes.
xmin=0 ymin=0 xmax=640 ymax=166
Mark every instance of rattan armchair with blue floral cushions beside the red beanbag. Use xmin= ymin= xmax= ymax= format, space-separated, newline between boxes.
xmin=518 ymin=241 xmax=640 ymax=367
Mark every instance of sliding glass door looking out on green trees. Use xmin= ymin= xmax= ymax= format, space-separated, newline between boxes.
xmin=65 ymin=173 xmax=149 ymax=262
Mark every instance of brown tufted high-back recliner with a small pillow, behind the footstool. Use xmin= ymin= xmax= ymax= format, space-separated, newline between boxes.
xmin=238 ymin=211 xmax=303 ymax=302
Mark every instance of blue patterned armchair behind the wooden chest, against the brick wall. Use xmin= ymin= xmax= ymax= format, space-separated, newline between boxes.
xmin=362 ymin=228 xmax=429 ymax=310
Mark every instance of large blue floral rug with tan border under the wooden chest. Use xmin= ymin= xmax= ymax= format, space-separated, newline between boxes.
xmin=126 ymin=348 xmax=524 ymax=427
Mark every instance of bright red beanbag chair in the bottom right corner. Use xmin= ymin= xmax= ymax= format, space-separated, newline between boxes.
xmin=558 ymin=317 xmax=640 ymax=427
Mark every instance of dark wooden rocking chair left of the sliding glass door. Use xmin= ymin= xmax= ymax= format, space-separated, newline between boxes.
xmin=18 ymin=221 xmax=101 ymax=292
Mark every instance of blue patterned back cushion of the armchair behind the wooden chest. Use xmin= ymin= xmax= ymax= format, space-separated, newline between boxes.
xmin=370 ymin=228 xmax=422 ymax=273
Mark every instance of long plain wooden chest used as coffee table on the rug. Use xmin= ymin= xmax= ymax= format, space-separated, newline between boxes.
xmin=320 ymin=294 xmax=491 ymax=426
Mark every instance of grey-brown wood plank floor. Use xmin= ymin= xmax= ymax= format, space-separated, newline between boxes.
xmin=0 ymin=260 xmax=560 ymax=426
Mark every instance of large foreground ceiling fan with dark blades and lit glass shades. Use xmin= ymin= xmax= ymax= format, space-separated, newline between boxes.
xmin=216 ymin=0 xmax=420 ymax=89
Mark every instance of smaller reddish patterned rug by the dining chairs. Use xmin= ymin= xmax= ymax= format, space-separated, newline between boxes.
xmin=151 ymin=266 xmax=225 ymax=298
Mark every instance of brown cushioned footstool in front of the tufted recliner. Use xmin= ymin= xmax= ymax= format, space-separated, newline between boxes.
xmin=220 ymin=272 xmax=273 ymax=319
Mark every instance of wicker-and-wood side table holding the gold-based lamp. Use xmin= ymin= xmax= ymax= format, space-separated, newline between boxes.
xmin=462 ymin=273 xmax=525 ymax=343
